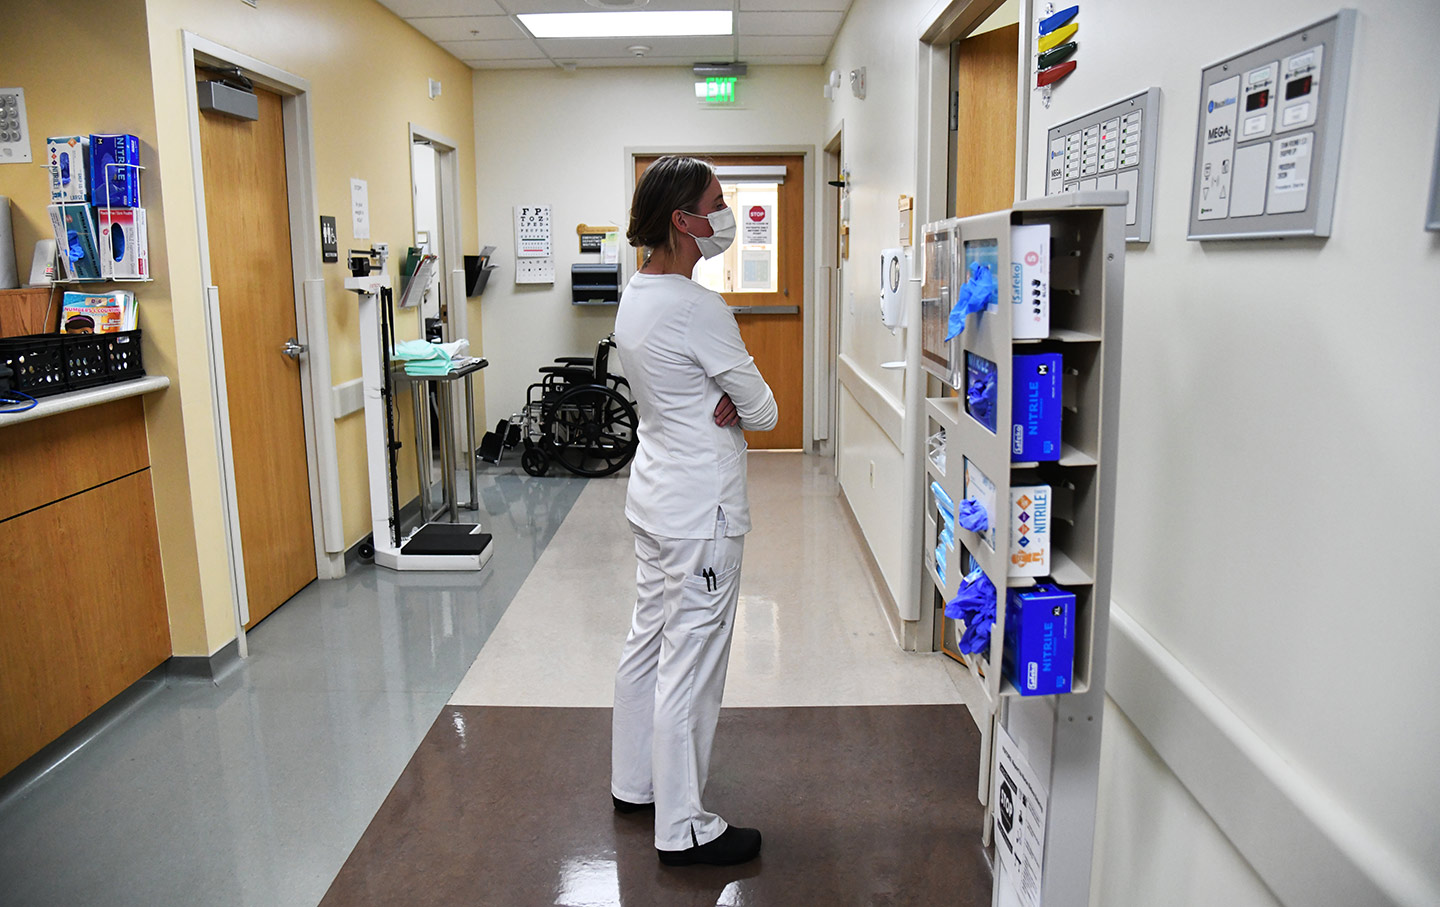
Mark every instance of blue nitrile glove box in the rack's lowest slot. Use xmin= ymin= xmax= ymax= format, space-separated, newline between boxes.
xmin=1004 ymin=583 xmax=1076 ymax=695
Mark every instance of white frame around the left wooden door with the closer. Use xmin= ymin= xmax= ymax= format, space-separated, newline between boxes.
xmin=181 ymin=32 xmax=346 ymax=655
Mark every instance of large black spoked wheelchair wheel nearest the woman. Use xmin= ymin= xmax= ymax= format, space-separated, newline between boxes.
xmin=541 ymin=384 xmax=639 ymax=478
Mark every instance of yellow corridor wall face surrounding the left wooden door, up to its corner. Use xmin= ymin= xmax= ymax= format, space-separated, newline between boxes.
xmin=147 ymin=0 xmax=480 ymax=652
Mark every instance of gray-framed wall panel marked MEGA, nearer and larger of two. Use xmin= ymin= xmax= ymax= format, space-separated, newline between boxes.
xmin=1188 ymin=10 xmax=1355 ymax=239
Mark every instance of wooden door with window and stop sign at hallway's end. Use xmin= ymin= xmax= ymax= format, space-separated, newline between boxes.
xmin=635 ymin=154 xmax=805 ymax=451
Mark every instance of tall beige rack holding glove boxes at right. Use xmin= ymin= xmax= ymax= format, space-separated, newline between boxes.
xmin=910 ymin=191 xmax=1126 ymax=907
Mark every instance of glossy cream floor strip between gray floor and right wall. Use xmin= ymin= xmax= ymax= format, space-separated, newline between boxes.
xmin=451 ymin=454 xmax=960 ymax=707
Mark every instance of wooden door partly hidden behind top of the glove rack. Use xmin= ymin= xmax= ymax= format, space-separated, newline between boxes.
xmin=955 ymin=24 xmax=1020 ymax=217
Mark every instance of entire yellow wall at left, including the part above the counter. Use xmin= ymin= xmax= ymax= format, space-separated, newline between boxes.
xmin=0 ymin=0 xmax=480 ymax=655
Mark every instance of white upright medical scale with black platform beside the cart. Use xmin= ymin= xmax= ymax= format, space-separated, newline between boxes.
xmin=346 ymin=243 xmax=492 ymax=570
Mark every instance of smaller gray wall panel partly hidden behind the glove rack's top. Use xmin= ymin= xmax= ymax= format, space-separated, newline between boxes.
xmin=1045 ymin=88 xmax=1161 ymax=242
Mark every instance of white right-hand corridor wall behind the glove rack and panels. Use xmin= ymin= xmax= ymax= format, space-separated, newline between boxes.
xmin=825 ymin=0 xmax=1440 ymax=907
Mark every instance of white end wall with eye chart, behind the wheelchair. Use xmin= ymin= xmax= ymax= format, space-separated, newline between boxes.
xmin=474 ymin=66 xmax=824 ymax=423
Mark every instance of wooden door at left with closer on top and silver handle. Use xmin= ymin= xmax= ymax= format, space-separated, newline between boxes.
xmin=200 ymin=89 xmax=315 ymax=626
